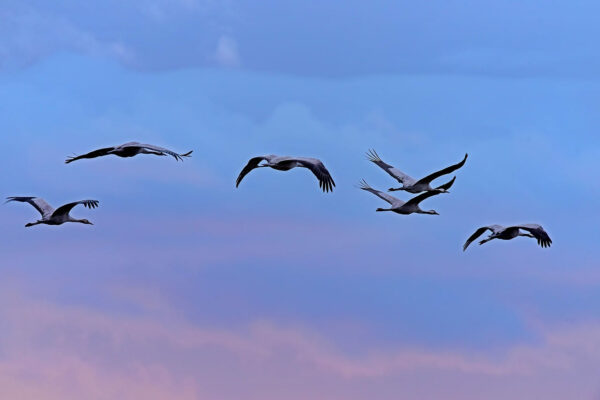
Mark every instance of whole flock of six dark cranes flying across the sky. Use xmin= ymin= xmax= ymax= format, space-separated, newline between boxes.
xmin=6 ymin=142 xmax=552 ymax=251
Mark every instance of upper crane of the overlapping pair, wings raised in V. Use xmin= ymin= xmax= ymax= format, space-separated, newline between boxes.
xmin=367 ymin=149 xmax=469 ymax=194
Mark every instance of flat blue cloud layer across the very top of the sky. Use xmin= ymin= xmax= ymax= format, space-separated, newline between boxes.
xmin=0 ymin=0 xmax=600 ymax=77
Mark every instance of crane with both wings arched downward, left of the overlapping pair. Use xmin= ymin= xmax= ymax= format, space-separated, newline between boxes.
xmin=235 ymin=154 xmax=335 ymax=192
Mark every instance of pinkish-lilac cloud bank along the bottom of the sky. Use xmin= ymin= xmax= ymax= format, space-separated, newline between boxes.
xmin=0 ymin=282 xmax=600 ymax=400
